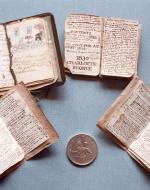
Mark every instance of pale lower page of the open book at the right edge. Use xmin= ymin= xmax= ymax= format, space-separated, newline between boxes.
xmin=128 ymin=123 xmax=150 ymax=169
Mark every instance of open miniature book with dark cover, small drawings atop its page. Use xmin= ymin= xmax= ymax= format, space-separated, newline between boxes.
xmin=0 ymin=13 xmax=64 ymax=95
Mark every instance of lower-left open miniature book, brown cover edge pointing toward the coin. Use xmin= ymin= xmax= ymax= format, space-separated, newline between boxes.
xmin=0 ymin=83 xmax=58 ymax=177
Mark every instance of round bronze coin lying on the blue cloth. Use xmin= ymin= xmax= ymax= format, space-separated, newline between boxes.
xmin=67 ymin=134 xmax=97 ymax=166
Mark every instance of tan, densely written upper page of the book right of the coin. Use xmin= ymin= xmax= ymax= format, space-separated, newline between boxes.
xmin=105 ymin=83 xmax=150 ymax=147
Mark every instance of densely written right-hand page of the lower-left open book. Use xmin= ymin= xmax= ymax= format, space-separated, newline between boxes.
xmin=0 ymin=84 xmax=57 ymax=159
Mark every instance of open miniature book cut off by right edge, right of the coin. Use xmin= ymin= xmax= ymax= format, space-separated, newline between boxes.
xmin=97 ymin=77 xmax=150 ymax=171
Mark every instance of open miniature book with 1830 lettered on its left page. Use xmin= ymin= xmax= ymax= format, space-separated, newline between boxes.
xmin=65 ymin=14 xmax=141 ymax=78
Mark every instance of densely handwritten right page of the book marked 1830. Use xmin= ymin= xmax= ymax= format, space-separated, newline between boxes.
xmin=101 ymin=18 xmax=140 ymax=77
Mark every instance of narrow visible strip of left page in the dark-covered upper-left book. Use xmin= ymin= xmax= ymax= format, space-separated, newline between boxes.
xmin=0 ymin=25 xmax=14 ymax=88
